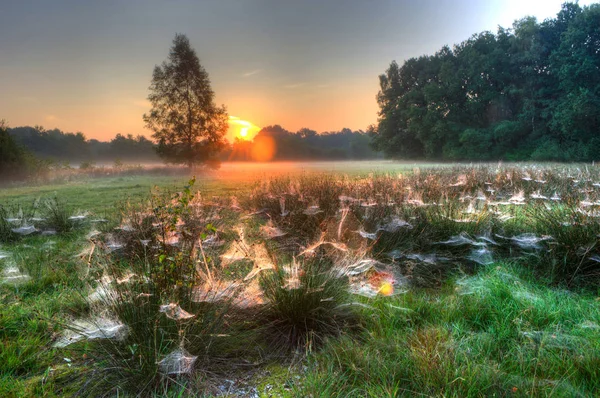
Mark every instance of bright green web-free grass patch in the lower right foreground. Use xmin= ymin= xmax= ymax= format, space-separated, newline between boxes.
xmin=298 ymin=264 xmax=600 ymax=397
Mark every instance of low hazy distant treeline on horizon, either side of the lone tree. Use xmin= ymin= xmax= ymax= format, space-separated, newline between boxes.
xmin=8 ymin=125 xmax=377 ymax=162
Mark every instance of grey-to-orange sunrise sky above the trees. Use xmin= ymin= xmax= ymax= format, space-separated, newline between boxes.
xmin=0 ymin=0 xmax=597 ymax=140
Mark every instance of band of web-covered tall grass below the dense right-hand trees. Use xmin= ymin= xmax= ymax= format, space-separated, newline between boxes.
xmin=244 ymin=167 xmax=600 ymax=284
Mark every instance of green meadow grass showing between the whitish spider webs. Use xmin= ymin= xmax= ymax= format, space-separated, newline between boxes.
xmin=0 ymin=162 xmax=600 ymax=397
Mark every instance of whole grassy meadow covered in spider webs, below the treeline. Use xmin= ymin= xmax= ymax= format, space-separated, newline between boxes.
xmin=0 ymin=161 xmax=600 ymax=397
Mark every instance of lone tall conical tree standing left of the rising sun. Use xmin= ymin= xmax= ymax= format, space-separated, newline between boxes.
xmin=144 ymin=34 xmax=228 ymax=168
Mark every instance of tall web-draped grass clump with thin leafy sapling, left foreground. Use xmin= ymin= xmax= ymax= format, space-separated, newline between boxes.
xmin=54 ymin=180 xmax=248 ymax=396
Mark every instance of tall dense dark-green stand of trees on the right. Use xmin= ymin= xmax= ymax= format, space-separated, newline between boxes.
xmin=369 ymin=3 xmax=600 ymax=161
